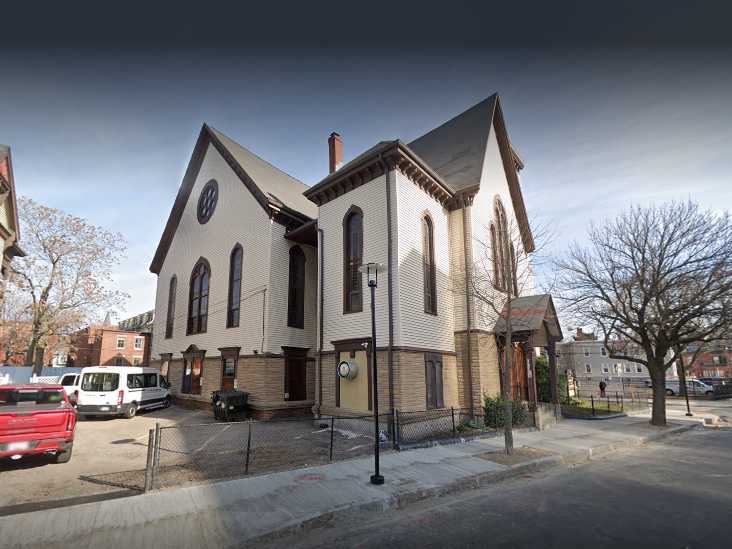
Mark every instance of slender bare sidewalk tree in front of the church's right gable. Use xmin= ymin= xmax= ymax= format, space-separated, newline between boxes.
xmin=454 ymin=205 xmax=550 ymax=455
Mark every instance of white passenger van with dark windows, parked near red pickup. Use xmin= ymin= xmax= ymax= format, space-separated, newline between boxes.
xmin=76 ymin=366 xmax=170 ymax=418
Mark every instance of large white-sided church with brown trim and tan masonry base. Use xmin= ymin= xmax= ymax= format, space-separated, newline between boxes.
xmin=150 ymin=95 xmax=558 ymax=417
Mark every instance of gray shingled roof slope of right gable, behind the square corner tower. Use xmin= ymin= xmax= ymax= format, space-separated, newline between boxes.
xmin=409 ymin=94 xmax=498 ymax=191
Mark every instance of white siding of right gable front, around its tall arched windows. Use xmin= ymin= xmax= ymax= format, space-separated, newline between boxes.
xmin=470 ymin=123 xmax=533 ymax=330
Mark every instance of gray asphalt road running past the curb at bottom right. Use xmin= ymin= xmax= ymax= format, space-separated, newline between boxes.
xmin=272 ymin=428 xmax=732 ymax=549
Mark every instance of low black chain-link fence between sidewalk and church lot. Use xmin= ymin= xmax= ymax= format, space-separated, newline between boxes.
xmin=145 ymin=408 xmax=512 ymax=490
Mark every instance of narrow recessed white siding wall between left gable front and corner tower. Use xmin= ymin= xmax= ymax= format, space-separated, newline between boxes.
xmin=266 ymin=223 xmax=318 ymax=353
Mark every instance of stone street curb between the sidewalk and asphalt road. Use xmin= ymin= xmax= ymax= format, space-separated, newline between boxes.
xmin=246 ymin=424 xmax=698 ymax=544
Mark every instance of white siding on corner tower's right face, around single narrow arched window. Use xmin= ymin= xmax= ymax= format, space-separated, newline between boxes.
xmin=393 ymin=172 xmax=455 ymax=351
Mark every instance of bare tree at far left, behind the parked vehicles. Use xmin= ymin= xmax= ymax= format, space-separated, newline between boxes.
xmin=11 ymin=198 xmax=127 ymax=370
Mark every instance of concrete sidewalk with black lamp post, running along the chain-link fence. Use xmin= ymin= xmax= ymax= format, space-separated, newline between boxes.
xmin=0 ymin=417 xmax=698 ymax=548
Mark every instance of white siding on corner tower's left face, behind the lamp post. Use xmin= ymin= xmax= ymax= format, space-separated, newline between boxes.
xmin=318 ymin=172 xmax=392 ymax=351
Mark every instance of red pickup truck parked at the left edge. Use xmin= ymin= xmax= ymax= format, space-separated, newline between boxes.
xmin=0 ymin=384 xmax=76 ymax=463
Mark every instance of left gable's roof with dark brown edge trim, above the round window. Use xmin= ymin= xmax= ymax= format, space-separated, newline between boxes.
xmin=150 ymin=124 xmax=318 ymax=274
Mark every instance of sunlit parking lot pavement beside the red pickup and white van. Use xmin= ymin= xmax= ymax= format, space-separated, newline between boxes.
xmin=0 ymin=406 xmax=206 ymax=514
